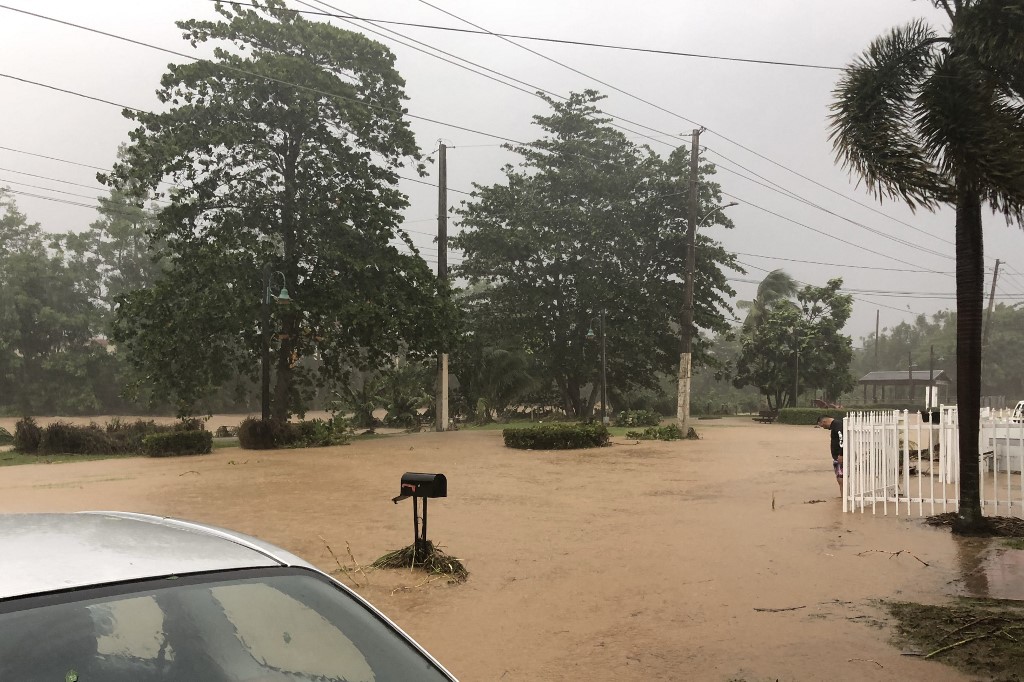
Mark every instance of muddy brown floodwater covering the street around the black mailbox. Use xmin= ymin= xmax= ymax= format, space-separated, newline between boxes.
xmin=0 ymin=416 xmax=1007 ymax=682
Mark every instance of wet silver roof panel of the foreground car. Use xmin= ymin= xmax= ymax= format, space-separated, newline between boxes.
xmin=0 ymin=512 xmax=309 ymax=599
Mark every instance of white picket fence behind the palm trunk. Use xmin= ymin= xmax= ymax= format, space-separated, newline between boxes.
xmin=843 ymin=406 xmax=1024 ymax=518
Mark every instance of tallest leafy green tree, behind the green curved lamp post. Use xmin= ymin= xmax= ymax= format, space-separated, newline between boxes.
xmin=101 ymin=0 xmax=442 ymax=420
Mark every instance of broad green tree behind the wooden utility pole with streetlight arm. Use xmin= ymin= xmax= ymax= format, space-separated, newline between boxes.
xmin=454 ymin=91 xmax=735 ymax=417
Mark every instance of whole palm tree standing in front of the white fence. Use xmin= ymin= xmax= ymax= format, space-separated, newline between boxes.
xmin=831 ymin=0 xmax=1024 ymax=532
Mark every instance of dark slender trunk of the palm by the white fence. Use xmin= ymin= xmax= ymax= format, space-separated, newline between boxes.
xmin=953 ymin=182 xmax=986 ymax=535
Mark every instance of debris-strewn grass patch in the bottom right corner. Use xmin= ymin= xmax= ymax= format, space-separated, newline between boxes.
xmin=885 ymin=599 xmax=1024 ymax=682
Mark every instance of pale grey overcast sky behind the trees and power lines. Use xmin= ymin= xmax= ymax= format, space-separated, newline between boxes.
xmin=0 ymin=0 xmax=1024 ymax=339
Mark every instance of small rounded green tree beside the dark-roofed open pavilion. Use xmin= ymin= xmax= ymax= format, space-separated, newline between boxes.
xmin=733 ymin=279 xmax=854 ymax=409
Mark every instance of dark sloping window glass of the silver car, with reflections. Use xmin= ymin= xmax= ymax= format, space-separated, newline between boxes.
xmin=0 ymin=569 xmax=450 ymax=682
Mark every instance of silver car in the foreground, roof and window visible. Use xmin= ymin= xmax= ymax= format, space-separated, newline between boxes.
xmin=0 ymin=512 xmax=455 ymax=682
